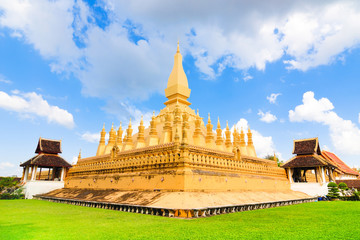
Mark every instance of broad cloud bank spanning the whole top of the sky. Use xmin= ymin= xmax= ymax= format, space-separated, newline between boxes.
xmin=0 ymin=0 xmax=360 ymax=107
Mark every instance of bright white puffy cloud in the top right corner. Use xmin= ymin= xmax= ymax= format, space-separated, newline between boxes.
xmin=280 ymin=1 xmax=360 ymax=71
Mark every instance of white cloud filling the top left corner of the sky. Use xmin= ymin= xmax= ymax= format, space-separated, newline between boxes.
xmin=0 ymin=0 xmax=81 ymax=72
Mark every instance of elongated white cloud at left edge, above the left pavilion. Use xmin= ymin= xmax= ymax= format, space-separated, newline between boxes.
xmin=0 ymin=90 xmax=75 ymax=128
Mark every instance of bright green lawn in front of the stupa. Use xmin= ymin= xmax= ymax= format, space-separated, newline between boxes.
xmin=0 ymin=200 xmax=360 ymax=240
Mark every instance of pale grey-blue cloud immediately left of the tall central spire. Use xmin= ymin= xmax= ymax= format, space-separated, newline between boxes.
xmin=77 ymin=23 xmax=175 ymax=101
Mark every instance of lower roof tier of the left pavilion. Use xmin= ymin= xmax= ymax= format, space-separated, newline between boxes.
xmin=20 ymin=154 xmax=71 ymax=167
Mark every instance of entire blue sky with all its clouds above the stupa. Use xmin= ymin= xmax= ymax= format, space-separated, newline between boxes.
xmin=0 ymin=0 xmax=360 ymax=176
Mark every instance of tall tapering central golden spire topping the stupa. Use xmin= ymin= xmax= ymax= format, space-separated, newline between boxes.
xmin=165 ymin=41 xmax=191 ymax=106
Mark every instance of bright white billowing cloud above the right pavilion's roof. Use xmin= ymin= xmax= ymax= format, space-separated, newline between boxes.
xmin=289 ymin=91 xmax=360 ymax=154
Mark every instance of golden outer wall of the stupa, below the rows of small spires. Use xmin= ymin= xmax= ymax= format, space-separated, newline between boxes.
xmin=65 ymin=143 xmax=290 ymax=192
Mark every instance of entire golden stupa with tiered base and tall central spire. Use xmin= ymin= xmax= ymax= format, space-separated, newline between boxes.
xmin=41 ymin=44 xmax=307 ymax=217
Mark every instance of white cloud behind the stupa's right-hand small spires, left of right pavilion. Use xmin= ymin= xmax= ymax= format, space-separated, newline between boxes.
xmin=228 ymin=118 xmax=282 ymax=159
